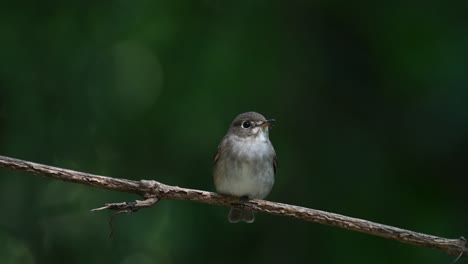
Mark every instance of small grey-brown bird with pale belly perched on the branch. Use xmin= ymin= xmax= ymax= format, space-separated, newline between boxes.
xmin=214 ymin=112 xmax=278 ymax=223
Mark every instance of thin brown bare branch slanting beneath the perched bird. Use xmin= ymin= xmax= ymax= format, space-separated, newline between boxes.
xmin=0 ymin=156 xmax=468 ymax=257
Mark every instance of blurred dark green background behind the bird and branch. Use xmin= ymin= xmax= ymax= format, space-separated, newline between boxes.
xmin=0 ymin=0 xmax=468 ymax=264
